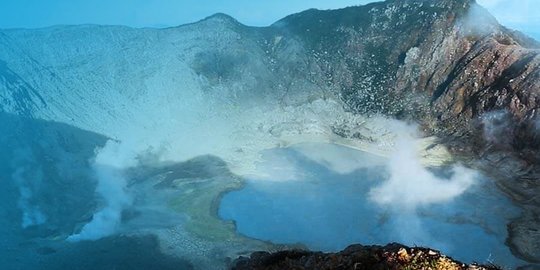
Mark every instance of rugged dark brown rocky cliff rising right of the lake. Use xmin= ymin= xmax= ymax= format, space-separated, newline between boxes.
xmin=275 ymin=0 xmax=540 ymax=261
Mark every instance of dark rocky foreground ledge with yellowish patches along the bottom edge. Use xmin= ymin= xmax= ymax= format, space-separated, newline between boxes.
xmin=232 ymin=244 xmax=500 ymax=270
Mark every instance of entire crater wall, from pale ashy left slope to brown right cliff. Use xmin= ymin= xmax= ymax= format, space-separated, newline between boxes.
xmin=0 ymin=0 xmax=540 ymax=261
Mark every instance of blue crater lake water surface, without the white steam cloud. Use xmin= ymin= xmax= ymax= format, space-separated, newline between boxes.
xmin=219 ymin=143 xmax=522 ymax=267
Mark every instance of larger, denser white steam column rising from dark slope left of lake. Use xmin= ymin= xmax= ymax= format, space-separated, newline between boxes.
xmin=68 ymin=140 xmax=137 ymax=241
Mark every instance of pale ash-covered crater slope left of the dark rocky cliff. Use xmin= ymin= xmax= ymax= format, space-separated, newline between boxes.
xmin=0 ymin=14 xmax=354 ymax=177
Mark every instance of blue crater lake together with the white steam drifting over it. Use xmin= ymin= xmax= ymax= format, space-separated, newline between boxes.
xmin=219 ymin=143 xmax=521 ymax=267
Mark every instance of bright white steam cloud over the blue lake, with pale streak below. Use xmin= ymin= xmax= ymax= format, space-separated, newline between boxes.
xmin=369 ymin=121 xmax=476 ymax=244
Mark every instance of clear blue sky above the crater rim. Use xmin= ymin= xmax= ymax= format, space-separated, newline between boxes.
xmin=0 ymin=0 xmax=540 ymax=39
